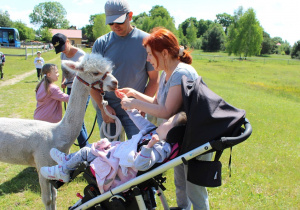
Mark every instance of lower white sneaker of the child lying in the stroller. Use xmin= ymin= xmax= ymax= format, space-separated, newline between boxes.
xmin=41 ymin=165 xmax=70 ymax=182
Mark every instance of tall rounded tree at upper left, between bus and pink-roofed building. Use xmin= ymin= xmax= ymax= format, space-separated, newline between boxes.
xmin=29 ymin=2 xmax=69 ymax=28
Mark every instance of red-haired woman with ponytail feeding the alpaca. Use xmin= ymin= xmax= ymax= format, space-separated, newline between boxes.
xmin=116 ymin=28 xmax=212 ymax=210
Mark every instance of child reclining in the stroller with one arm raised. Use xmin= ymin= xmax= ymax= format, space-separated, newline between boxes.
xmin=41 ymin=109 xmax=186 ymax=193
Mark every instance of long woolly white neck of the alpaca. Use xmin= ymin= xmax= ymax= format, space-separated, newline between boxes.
xmin=58 ymin=79 xmax=89 ymax=147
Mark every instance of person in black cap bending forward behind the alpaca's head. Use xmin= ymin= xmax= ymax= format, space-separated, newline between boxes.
xmin=52 ymin=33 xmax=90 ymax=148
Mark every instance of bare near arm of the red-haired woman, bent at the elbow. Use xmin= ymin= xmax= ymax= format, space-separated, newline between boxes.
xmin=121 ymin=85 xmax=182 ymax=119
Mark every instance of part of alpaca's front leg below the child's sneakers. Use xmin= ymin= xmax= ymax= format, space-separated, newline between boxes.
xmin=39 ymin=174 xmax=56 ymax=210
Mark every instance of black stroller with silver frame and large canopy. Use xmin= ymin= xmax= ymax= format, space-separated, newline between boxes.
xmin=51 ymin=77 xmax=252 ymax=210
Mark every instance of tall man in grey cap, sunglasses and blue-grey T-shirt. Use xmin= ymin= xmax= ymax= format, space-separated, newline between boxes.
xmin=90 ymin=0 xmax=159 ymax=140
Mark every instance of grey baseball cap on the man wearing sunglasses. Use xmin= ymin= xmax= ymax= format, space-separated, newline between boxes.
xmin=104 ymin=0 xmax=130 ymax=24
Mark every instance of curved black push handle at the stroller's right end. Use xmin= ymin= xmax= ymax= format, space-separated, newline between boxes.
xmin=210 ymin=118 xmax=252 ymax=150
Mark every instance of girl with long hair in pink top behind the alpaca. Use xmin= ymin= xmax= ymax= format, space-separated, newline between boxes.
xmin=33 ymin=64 xmax=69 ymax=123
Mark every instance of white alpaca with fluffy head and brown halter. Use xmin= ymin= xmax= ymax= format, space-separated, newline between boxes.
xmin=0 ymin=54 xmax=118 ymax=209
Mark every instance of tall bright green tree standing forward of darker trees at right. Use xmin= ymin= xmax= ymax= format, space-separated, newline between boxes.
xmin=226 ymin=8 xmax=263 ymax=57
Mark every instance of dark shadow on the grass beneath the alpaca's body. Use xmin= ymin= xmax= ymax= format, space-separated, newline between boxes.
xmin=0 ymin=167 xmax=41 ymax=196
